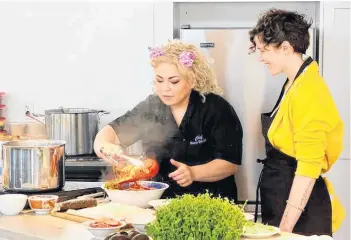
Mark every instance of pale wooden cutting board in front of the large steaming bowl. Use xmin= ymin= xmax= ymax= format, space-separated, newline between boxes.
xmin=51 ymin=202 xmax=153 ymax=222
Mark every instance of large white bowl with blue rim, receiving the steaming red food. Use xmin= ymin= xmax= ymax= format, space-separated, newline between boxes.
xmin=101 ymin=181 xmax=169 ymax=208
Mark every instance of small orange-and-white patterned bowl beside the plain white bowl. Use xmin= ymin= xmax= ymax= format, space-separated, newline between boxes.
xmin=28 ymin=195 xmax=58 ymax=214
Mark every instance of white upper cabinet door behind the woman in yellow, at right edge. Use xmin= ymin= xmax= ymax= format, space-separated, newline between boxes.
xmin=321 ymin=1 xmax=351 ymax=159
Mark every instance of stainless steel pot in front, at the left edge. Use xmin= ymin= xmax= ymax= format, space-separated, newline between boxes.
xmin=1 ymin=140 xmax=66 ymax=192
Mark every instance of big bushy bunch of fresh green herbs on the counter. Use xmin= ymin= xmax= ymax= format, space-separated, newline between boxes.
xmin=145 ymin=193 xmax=248 ymax=240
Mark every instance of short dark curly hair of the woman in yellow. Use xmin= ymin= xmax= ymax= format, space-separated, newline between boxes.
xmin=249 ymin=9 xmax=312 ymax=54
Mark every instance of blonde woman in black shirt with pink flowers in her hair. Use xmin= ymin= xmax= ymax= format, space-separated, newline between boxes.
xmin=94 ymin=40 xmax=243 ymax=200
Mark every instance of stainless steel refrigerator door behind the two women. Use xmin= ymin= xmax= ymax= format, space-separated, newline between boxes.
xmin=181 ymin=29 xmax=313 ymax=202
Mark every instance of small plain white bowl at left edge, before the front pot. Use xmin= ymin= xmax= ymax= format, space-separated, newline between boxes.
xmin=0 ymin=194 xmax=28 ymax=216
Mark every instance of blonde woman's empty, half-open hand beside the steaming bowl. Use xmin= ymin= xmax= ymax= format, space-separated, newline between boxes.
xmin=168 ymin=159 xmax=193 ymax=187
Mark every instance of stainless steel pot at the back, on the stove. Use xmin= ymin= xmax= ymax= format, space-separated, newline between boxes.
xmin=26 ymin=108 xmax=108 ymax=156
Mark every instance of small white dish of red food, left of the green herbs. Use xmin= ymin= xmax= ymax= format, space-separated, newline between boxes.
xmin=82 ymin=219 xmax=126 ymax=238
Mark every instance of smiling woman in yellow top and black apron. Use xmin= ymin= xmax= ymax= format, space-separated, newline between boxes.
xmin=250 ymin=10 xmax=344 ymax=235
